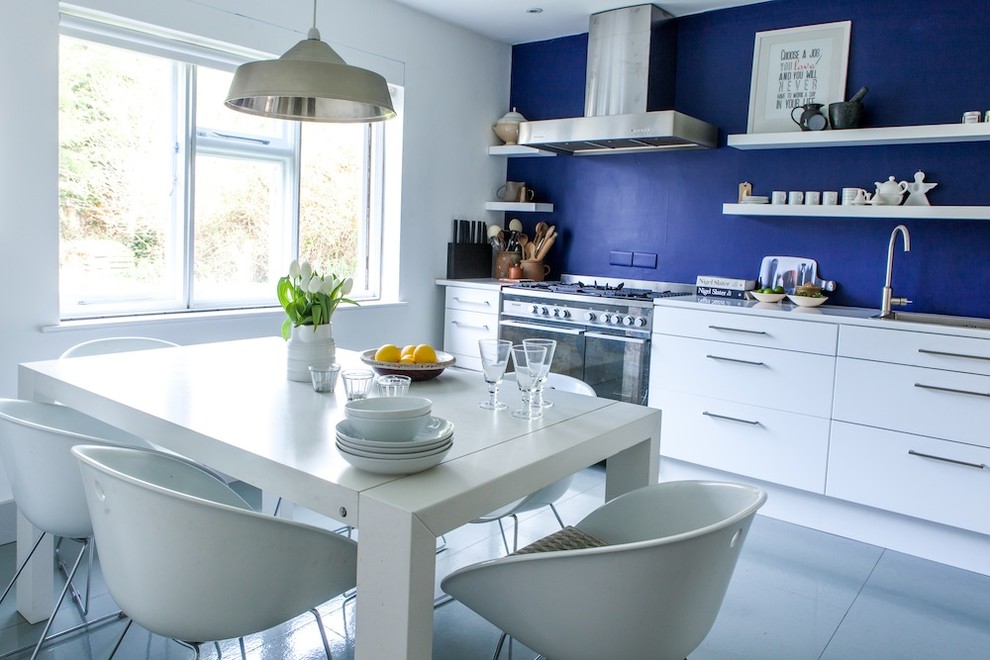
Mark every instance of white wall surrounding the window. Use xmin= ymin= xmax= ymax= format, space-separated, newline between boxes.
xmin=0 ymin=0 xmax=511 ymax=506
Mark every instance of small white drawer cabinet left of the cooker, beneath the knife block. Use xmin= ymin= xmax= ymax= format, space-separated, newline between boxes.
xmin=443 ymin=286 xmax=501 ymax=371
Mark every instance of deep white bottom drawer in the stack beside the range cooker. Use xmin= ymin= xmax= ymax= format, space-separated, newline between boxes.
xmin=650 ymin=392 xmax=829 ymax=493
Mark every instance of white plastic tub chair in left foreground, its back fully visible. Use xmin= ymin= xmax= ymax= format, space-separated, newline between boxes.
xmin=72 ymin=446 xmax=357 ymax=658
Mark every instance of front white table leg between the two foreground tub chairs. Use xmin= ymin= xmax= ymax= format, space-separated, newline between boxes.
xmin=354 ymin=498 xmax=436 ymax=660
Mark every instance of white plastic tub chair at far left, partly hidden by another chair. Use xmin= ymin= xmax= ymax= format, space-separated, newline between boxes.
xmin=0 ymin=399 xmax=156 ymax=658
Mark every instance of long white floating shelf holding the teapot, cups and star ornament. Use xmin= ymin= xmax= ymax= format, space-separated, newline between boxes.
xmin=722 ymin=204 xmax=990 ymax=220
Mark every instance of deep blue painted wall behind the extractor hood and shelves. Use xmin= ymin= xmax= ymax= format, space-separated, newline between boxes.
xmin=507 ymin=0 xmax=990 ymax=317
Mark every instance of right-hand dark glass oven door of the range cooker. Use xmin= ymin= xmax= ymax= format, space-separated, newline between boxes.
xmin=584 ymin=331 xmax=650 ymax=406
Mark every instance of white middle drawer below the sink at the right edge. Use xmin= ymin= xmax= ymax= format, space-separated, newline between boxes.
xmin=832 ymin=357 xmax=990 ymax=447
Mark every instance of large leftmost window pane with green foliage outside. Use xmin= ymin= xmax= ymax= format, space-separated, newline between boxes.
xmin=59 ymin=37 xmax=181 ymax=309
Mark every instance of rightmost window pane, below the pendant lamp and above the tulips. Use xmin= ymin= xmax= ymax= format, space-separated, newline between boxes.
xmin=299 ymin=122 xmax=369 ymax=288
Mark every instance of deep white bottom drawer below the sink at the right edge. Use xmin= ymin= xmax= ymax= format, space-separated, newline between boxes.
xmin=828 ymin=422 xmax=990 ymax=534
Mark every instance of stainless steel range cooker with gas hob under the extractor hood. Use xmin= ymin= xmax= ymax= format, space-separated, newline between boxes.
xmin=499 ymin=275 xmax=694 ymax=405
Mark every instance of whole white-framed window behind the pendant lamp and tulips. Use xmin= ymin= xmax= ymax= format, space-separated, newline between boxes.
xmin=59 ymin=16 xmax=399 ymax=319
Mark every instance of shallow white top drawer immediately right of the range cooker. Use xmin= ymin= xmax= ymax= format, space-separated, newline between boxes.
xmin=653 ymin=306 xmax=838 ymax=355
